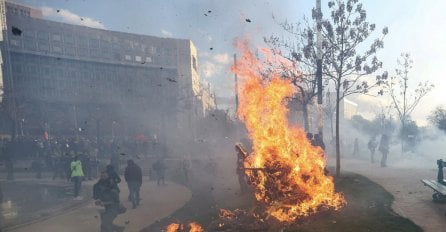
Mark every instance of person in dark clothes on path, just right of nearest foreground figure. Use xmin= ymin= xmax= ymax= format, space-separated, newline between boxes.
xmin=124 ymin=159 xmax=142 ymax=209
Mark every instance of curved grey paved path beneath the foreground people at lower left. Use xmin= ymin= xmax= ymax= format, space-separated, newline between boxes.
xmin=13 ymin=179 xmax=192 ymax=232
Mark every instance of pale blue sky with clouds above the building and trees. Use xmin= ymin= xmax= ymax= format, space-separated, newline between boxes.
xmin=12 ymin=0 xmax=446 ymax=124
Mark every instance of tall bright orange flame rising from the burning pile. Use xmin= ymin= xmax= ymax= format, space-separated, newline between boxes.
xmin=232 ymin=39 xmax=345 ymax=222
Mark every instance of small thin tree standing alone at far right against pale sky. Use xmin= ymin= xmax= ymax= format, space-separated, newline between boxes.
xmin=386 ymin=53 xmax=434 ymax=152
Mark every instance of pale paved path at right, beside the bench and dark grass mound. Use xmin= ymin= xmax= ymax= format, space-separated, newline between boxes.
xmin=342 ymin=159 xmax=446 ymax=232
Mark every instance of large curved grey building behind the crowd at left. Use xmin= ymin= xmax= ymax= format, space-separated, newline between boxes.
xmin=0 ymin=1 xmax=215 ymax=140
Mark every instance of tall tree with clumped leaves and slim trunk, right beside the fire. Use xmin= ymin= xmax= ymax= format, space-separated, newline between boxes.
xmin=318 ymin=0 xmax=388 ymax=176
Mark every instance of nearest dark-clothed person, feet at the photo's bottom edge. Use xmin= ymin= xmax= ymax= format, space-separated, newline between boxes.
xmin=93 ymin=171 xmax=125 ymax=232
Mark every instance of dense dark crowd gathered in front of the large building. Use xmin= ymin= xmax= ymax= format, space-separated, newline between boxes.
xmin=0 ymin=137 xmax=165 ymax=181
